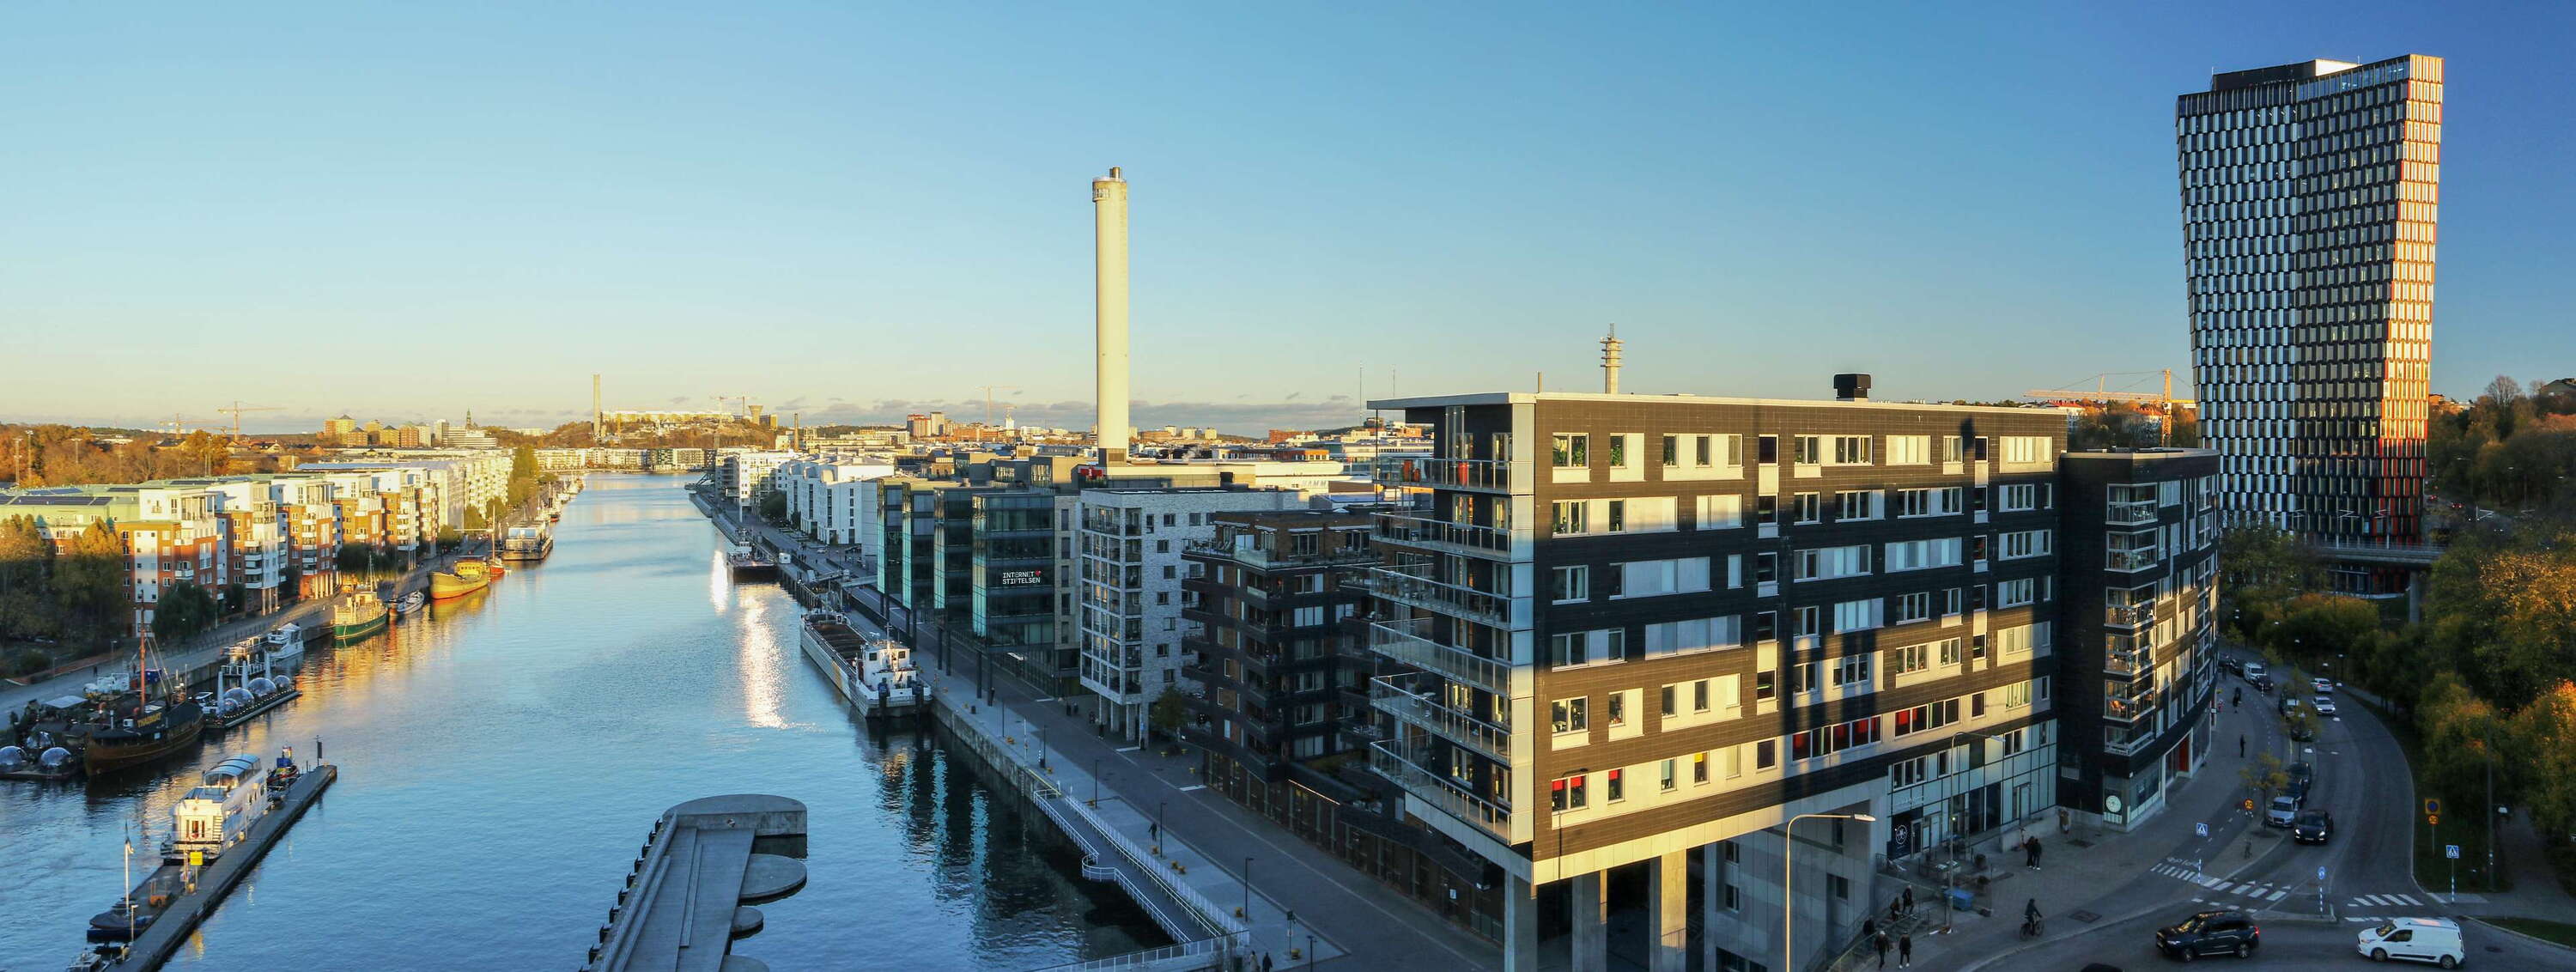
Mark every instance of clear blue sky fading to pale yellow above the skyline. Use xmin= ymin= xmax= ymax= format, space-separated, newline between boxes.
xmin=0 ymin=3 xmax=2576 ymax=430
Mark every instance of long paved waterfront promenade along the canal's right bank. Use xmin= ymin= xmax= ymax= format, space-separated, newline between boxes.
xmin=716 ymin=503 xmax=1502 ymax=969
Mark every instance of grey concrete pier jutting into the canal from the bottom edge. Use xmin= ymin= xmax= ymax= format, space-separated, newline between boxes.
xmin=582 ymin=794 xmax=806 ymax=972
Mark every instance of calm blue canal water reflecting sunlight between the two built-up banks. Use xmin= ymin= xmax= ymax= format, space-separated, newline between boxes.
xmin=0 ymin=474 xmax=1164 ymax=972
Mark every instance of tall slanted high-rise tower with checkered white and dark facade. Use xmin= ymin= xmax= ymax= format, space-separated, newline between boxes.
xmin=2174 ymin=54 xmax=2442 ymax=551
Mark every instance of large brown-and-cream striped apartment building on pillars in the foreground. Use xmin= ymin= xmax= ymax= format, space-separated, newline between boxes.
xmin=1370 ymin=376 xmax=2066 ymax=969
